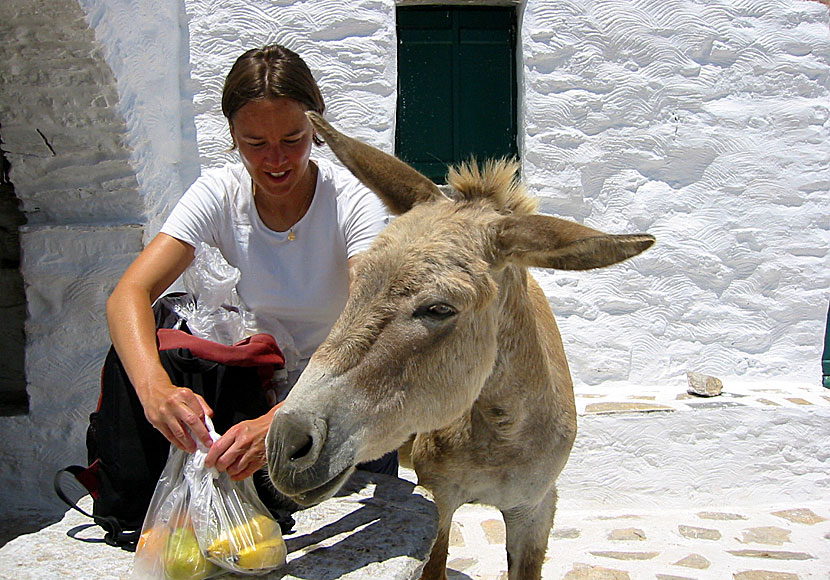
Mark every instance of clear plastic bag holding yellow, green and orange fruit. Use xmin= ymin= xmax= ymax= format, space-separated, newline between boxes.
xmin=130 ymin=417 xmax=286 ymax=580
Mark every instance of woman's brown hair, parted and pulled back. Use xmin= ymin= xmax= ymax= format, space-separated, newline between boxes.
xmin=222 ymin=44 xmax=326 ymax=145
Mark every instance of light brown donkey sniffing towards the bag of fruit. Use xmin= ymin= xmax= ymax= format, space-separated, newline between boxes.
xmin=266 ymin=112 xmax=654 ymax=580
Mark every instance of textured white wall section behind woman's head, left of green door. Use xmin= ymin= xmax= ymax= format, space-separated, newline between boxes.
xmin=186 ymin=0 xmax=397 ymax=166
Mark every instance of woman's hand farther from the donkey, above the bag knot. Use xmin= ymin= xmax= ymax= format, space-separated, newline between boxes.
xmin=141 ymin=380 xmax=213 ymax=453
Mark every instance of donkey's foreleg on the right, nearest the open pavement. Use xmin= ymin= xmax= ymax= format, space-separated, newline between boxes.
xmin=502 ymin=486 xmax=556 ymax=580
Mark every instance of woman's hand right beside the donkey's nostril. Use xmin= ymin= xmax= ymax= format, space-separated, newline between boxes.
xmin=205 ymin=404 xmax=281 ymax=481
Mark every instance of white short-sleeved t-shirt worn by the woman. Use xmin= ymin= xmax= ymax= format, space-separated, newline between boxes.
xmin=161 ymin=159 xmax=389 ymax=368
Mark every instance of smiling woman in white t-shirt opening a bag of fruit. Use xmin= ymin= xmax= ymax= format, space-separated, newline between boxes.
xmin=107 ymin=45 xmax=396 ymax=488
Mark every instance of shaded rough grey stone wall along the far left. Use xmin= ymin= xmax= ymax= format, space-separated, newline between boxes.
xmin=0 ymin=0 xmax=143 ymax=512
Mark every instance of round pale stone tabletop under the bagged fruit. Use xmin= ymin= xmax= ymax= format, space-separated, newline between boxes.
xmin=0 ymin=472 xmax=438 ymax=580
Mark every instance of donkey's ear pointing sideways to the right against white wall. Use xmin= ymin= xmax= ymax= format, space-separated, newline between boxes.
xmin=497 ymin=215 xmax=654 ymax=270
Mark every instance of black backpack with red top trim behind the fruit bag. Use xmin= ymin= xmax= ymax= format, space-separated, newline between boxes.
xmin=55 ymin=295 xmax=293 ymax=551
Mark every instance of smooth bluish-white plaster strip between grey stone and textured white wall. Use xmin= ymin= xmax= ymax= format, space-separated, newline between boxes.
xmin=79 ymin=0 xmax=199 ymax=243
